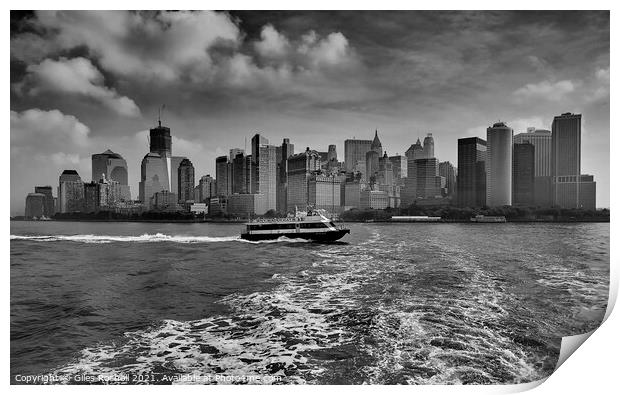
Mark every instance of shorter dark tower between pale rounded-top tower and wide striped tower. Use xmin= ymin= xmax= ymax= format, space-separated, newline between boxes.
xmin=512 ymin=142 xmax=536 ymax=206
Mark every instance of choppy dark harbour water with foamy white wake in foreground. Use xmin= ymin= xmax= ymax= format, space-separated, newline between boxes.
xmin=11 ymin=222 xmax=609 ymax=384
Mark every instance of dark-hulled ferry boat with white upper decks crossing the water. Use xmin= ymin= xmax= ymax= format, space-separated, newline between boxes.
xmin=241 ymin=209 xmax=351 ymax=242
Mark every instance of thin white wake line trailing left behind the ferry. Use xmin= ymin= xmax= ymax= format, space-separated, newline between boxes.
xmin=11 ymin=233 xmax=307 ymax=244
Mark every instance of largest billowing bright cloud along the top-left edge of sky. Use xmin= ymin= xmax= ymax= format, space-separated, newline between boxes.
xmin=26 ymin=11 xmax=239 ymax=81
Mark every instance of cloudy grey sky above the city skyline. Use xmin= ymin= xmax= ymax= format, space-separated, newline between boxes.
xmin=10 ymin=11 xmax=610 ymax=215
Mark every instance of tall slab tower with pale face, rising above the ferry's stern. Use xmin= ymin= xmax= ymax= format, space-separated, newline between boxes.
xmin=250 ymin=134 xmax=277 ymax=211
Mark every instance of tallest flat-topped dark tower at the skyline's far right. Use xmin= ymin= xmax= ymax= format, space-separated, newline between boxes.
xmin=551 ymin=112 xmax=581 ymax=208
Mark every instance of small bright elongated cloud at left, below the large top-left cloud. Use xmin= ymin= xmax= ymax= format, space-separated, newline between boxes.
xmin=26 ymin=58 xmax=140 ymax=117
